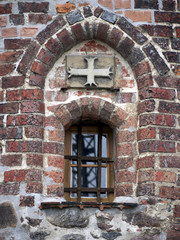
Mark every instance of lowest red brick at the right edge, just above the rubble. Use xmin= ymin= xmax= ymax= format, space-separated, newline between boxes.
xmin=159 ymin=186 xmax=180 ymax=200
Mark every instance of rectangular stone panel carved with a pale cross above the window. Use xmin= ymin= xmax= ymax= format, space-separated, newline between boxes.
xmin=66 ymin=55 xmax=115 ymax=88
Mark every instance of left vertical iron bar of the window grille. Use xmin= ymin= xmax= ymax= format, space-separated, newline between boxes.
xmin=77 ymin=125 xmax=82 ymax=202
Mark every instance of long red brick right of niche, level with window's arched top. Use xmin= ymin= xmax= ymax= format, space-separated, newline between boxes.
xmin=140 ymin=113 xmax=176 ymax=127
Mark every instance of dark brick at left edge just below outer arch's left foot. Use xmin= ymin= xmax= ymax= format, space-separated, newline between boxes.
xmin=2 ymin=76 xmax=25 ymax=89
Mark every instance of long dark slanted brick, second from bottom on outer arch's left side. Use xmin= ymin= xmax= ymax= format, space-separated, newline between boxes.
xmin=36 ymin=15 xmax=66 ymax=44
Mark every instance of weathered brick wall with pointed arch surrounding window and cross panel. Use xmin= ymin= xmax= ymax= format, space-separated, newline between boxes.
xmin=0 ymin=0 xmax=180 ymax=240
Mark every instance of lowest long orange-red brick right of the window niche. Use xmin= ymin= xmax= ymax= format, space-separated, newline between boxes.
xmin=138 ymin=170 xmax=176 ymax=183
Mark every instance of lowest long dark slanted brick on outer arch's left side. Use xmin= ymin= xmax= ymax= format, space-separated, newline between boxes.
xmin=17 ymin=42 xmax=40 ymax=75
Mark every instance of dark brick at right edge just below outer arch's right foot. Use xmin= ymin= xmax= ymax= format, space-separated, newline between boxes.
xmin=155 ymin=76 xmax=180 ymax=88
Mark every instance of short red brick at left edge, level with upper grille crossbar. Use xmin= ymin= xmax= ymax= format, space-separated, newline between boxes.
xmin=0 ymin=154 xmax=22 ymax=166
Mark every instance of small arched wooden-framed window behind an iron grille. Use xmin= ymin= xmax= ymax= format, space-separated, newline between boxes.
xmin=64 ymin=123 xmax=114 ymax=203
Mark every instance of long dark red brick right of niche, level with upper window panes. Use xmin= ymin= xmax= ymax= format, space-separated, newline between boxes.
xmin=139 ymin=140 xmax=176 ymax=153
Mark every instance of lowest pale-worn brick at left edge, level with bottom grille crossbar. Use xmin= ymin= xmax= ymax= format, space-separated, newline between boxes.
xmin=0 ymin=183 xmax=20 ymax=195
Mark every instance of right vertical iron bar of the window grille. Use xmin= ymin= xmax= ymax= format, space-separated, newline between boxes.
xmin=97 ymin=125 xmax=102 ymax=203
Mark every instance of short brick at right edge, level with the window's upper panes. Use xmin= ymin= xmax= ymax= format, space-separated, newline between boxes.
xmin=159 ymin=128 xmax=180 ymax=141
